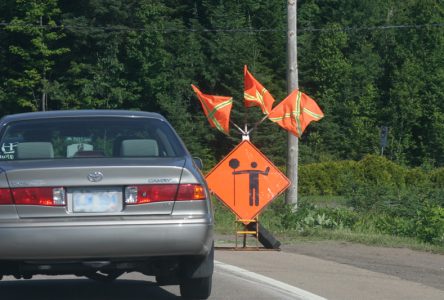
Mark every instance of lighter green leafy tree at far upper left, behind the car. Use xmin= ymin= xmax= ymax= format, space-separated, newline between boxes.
xmin=6 ymin=0 xmax=69 ymax=111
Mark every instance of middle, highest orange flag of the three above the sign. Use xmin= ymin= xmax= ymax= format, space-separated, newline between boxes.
xmin=244 ymin=66 xmax=274 ymax=115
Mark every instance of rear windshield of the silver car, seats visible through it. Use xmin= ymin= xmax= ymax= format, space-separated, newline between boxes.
xmin=0 ymin=117 xmax=185 ymax=160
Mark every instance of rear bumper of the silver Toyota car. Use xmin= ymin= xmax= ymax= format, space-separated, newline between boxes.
xmin=0 ymin=217 xmax=213 ymax=260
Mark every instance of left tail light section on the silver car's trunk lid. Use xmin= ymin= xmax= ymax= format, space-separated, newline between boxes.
xmin=11 ymin=187 xmax=66 ymax=206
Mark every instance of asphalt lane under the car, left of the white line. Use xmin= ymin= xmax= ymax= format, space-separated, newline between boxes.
xmin=0 ymin=267 xmax=302 ymax=300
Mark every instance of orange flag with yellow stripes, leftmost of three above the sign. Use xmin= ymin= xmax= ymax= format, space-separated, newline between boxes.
xmin=191 ymin=84 xmax=233 ymax=135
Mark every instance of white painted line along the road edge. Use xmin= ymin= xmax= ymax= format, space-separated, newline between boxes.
xmin=214 ymin=260 xmax=326 ymax=300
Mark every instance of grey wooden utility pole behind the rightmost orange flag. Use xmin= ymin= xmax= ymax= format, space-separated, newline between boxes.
xmin=285 ymin=0 xmax=299 ymax=208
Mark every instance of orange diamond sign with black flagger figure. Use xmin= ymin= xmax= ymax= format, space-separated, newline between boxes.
xmin=206 ymin=141 xmax=290 ymax=219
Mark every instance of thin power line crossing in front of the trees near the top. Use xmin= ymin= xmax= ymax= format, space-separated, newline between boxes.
xmin=0 ymin=22 xmax=444 ymax=33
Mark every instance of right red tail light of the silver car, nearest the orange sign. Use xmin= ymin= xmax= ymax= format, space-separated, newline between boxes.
xmin=125 ymin=184 xmax=206 ymax=204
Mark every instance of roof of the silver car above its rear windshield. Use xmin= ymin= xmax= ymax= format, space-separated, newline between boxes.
xmin=0 ymin=109 xmax=166 ymax=123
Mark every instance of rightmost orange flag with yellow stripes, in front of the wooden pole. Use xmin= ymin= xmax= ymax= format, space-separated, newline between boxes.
xmin=268 ymin=89 xmax=324 ymax=137
